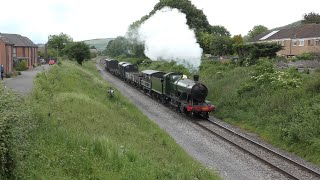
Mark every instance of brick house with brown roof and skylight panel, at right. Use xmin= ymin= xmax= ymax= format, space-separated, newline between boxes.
xmin=253 ymin=24 xmax=320 ymax=57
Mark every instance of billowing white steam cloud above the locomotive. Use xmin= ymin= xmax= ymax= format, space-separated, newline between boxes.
xmin=138 ymin=7 xmax=202 ymax=70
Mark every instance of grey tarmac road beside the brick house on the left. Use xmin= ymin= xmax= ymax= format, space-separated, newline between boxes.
xmin=4 ymin=64 xmax=49 ymax=96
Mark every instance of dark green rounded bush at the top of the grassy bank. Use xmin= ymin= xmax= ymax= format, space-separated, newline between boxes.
xmin=64 ymin=41 xmax=90 ymax=65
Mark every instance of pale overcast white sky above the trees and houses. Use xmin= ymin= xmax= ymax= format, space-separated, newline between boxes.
xmin=0 ymin=0 xmax=320 ymax=43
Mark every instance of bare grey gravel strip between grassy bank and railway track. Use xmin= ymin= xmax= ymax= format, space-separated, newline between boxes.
xmin=97 ymin=64 xmax=288 ymax=180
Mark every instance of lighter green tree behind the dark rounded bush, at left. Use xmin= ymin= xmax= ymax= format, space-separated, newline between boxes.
xmin=47 ymin=33 xmax=73 ymax=53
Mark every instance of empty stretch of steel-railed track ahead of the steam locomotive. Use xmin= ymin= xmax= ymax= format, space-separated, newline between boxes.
xmin=191 ymin=118 xmax=320 ymax=180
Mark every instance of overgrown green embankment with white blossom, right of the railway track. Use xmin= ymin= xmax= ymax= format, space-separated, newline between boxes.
xmin=200 ymin=59 xmax=320 ymax=165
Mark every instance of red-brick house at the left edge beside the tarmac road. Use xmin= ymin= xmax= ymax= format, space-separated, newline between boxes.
xmin=0 ymin=33 xmax=38 ymax=73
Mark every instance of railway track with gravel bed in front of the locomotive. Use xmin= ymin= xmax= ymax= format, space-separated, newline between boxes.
xmin=194 ymin=118 xmax=320 ymax=180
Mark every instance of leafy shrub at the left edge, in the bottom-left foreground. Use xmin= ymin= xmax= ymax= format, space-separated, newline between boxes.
xmin=0 ymin=82 xmax=32 ymax=179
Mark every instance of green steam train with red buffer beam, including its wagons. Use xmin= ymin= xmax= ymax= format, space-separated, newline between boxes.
xmin=105 ymin=59 xmax=216 ymax=118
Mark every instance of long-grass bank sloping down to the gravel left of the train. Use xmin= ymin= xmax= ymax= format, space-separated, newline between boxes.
xmin=16 ymin=61 xmax=217 ymax=179
